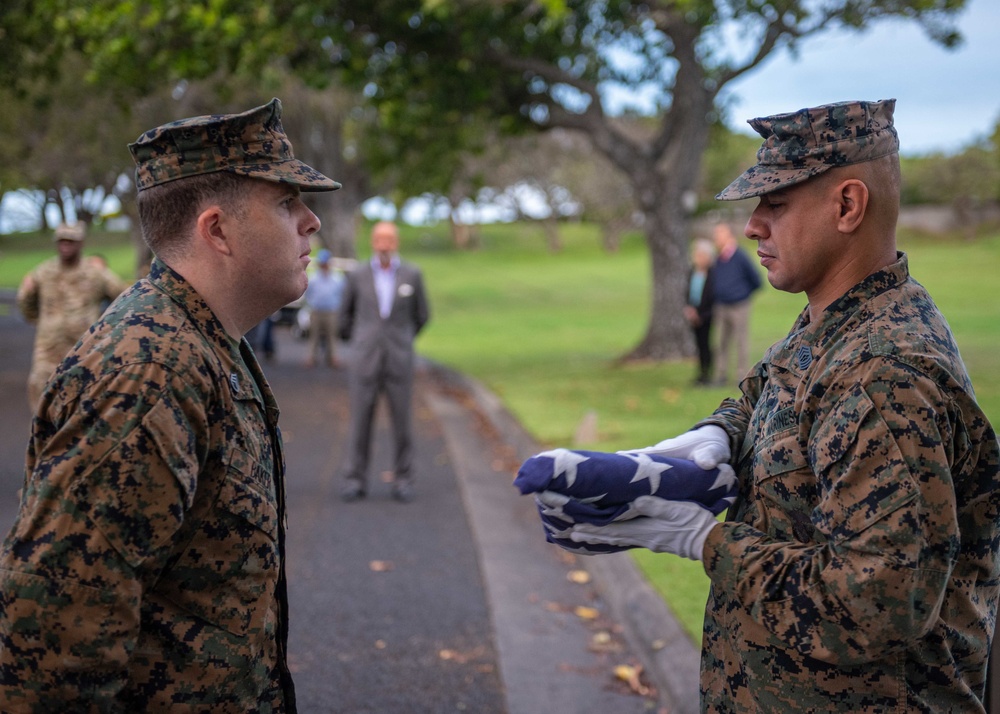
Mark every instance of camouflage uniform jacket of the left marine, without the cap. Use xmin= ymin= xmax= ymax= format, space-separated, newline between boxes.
xmin=0 ymin=261 xmax=295 ymax=714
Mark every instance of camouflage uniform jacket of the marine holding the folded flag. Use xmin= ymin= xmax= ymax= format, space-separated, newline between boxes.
xmin=701 ymin=254 xmax=1000 ymax=714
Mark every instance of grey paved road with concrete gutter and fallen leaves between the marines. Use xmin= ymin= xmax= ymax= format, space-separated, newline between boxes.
xmin=0 ymin=296 xmax=684 ymax=714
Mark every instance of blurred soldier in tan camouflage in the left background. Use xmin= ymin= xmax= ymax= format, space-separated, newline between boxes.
xmin=17 ymin=223 xmax=126 ymax=410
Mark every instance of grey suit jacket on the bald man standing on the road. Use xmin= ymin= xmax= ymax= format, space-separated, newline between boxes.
xmin=340 ymin=261 xmax=430 ymax=379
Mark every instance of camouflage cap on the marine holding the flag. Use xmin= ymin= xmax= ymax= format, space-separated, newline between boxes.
xmin=716 ymin=99 xmax=899 ymax=201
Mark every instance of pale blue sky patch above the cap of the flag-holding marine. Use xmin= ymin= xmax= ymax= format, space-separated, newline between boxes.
xmin=728 ymin=0 xmax=1000 ymax=155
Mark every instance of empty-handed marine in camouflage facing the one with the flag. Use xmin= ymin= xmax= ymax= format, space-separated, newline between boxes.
xmin=0 ymin=100 xmax=339 ymax=714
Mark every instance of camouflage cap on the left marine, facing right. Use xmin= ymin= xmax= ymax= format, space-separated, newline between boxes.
xmin=128 ymin=99 xmax=340 ymax=191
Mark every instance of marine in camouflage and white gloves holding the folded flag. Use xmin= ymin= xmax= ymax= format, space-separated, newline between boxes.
xmin=556 ymin=100 xmax=1000 ymax=714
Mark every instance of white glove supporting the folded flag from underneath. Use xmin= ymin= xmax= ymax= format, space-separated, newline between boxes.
xmin=563 ymin=496 xmax=719 ymax=560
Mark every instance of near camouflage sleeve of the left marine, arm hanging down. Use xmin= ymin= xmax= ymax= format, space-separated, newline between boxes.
xmin=0 ymin=364 xmax=207 ymax=712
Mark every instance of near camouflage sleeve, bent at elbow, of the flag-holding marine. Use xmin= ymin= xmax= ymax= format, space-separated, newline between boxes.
xmin=704 ymin=364 xmax=961 ymax=665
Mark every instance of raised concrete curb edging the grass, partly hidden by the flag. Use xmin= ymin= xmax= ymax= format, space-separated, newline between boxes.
xmin=422 ymin=360 xmax=700 ymax=714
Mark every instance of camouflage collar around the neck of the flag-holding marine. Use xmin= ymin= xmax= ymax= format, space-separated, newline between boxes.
xmin=765 ymin=252 xmax=910 ymax=373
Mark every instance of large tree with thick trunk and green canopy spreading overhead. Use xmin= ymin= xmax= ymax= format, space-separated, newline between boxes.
xmin=5 ymin=0 xmax=964 ymax=359
